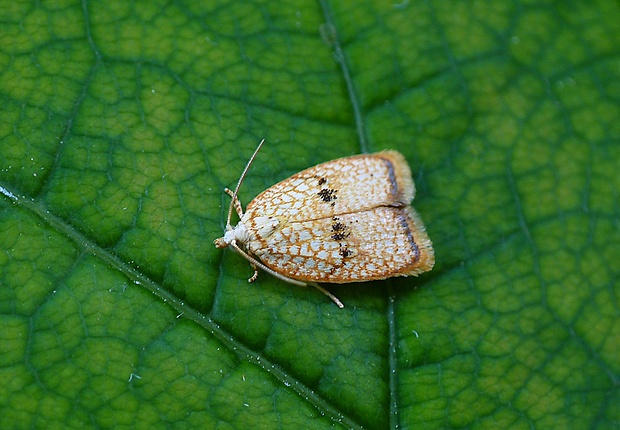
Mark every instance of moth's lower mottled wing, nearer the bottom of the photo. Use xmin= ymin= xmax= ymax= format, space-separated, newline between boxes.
xmin=249 ymin=206 xmax=434 ymax=283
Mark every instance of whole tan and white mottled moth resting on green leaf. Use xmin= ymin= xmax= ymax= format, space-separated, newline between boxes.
xmin=214 ymin=139 xmax=435 ymax=308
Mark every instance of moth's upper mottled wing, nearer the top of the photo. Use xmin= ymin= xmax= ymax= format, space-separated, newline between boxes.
xmin=244 ymin=151 xmax=415 ymax=222
